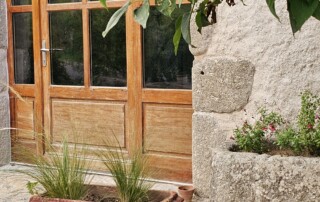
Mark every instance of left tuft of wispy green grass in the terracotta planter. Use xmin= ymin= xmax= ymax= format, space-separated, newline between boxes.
xmin=18 ymin=139 xmax=90 ymax=200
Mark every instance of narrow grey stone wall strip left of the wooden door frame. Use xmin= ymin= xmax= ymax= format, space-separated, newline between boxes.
xmin=0 ymin=1 xmax=11 ymax=165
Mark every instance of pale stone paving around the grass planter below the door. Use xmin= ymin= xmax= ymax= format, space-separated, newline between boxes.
xmin=0 ymin=165 xmax=181 ymax=202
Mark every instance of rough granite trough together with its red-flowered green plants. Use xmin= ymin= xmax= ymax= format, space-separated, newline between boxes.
xmin=211 ymin=91 xmax=320 ymax=201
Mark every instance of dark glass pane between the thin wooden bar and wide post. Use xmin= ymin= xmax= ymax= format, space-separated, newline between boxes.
xmin=90 ymin=10 xmax=127 ymax=87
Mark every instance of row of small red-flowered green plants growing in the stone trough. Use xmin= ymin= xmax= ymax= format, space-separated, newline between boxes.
xmin=232 ymin=91 xmax=320 ymax=156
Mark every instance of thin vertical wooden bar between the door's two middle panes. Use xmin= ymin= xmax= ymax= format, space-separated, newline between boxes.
xmin=82 ymin=8 xmax=91 ymax=88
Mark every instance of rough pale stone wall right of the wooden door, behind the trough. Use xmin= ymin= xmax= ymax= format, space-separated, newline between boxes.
xmin=191 ymin=0 xmax=320 ymax=201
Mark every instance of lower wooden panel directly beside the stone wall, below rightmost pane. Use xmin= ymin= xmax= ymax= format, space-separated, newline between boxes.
xmin=143 ymin=104 xmax=192 ymax=155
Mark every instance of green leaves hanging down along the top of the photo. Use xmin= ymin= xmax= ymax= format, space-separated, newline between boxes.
xmin=100 ymin=0 xmax=320 ymax=53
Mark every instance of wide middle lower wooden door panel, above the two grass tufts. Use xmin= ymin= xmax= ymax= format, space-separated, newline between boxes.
xmin=51 ymin=99 xmax=125 ymax=147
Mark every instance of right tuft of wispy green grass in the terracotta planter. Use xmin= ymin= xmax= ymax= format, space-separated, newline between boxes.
xmin=97 ymin=139 xmax=153 ymax=202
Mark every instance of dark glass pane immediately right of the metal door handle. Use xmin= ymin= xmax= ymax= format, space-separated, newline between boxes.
xmin=49 ymin=11 xmax=83 ymax=85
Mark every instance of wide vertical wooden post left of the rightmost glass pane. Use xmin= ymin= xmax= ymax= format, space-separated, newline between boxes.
xmin=126 ymin=4 xmax=142 ymax=152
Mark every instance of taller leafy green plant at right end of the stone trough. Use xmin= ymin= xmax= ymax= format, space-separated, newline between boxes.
xmin=277 ymin=91 xmax=320 ymax=156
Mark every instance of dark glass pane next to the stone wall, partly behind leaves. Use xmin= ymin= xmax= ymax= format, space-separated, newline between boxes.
xmin=143 ymin=5 xmax=194 ymax=89
